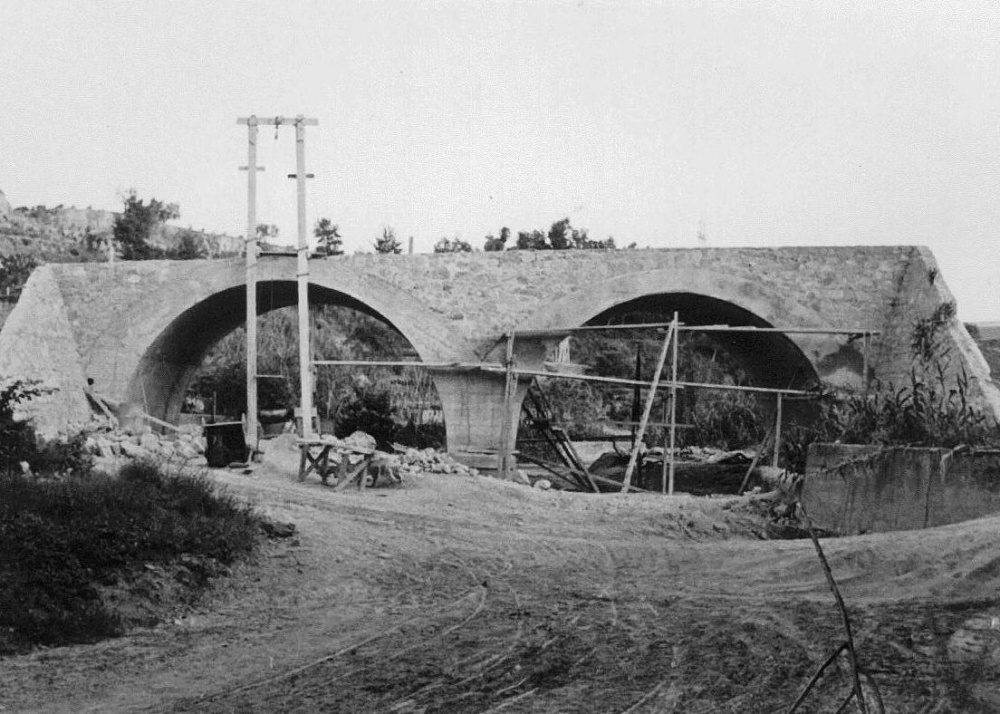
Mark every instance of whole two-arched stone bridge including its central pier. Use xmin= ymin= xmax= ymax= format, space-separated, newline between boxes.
xmin=0 ymin=246 xmax=1000 ymax=464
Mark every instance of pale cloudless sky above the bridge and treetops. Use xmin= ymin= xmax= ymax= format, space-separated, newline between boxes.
xmin=0 ymin=0 xmax=1000 ymax=321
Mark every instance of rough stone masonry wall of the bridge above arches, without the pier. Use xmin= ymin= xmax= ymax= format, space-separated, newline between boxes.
xmin=0 ymin=246 xmax=1000 ymax=434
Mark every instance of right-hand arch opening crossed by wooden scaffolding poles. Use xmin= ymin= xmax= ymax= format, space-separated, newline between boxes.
xmin=518 ymin=292 xmax=820 ymax=493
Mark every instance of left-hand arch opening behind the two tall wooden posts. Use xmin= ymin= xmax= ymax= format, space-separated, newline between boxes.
xmin=127 ymin=280 xmax=444 ymax=445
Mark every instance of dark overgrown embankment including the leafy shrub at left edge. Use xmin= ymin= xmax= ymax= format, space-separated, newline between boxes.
xmin=0 ymin=381 xmax=274 ymax=655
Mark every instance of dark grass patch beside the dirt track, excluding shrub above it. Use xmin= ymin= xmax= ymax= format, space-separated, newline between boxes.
xmin=0 ymin=461 xmax=262 ymax=654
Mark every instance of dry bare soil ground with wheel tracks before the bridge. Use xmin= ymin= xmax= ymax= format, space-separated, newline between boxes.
xmin=0 ymin=440 xmax=1000 ymax=714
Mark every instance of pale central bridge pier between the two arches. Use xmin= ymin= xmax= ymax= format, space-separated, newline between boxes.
xmin=434 ymin=370 xmax=530 ymax=470
